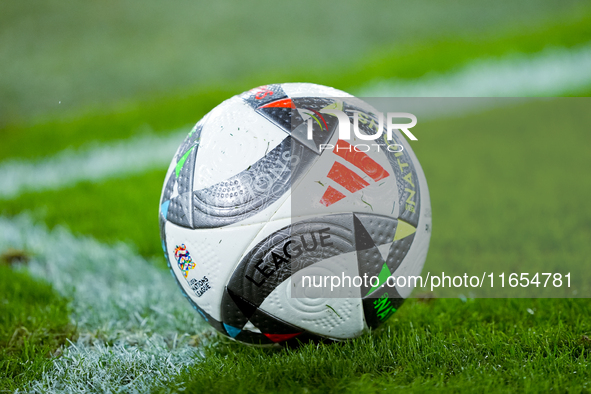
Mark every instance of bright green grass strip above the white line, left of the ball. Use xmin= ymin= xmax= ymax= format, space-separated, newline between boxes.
xmin=0 ymin=89 xmax=231 ymax=160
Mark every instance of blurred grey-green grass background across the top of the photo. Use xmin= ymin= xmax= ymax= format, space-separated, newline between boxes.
xmin=0 ymin=0 xmax=588 ymax=124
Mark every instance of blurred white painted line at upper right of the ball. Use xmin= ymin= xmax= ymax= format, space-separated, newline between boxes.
xmin=354 ymin=43 xmax=591 ymax=97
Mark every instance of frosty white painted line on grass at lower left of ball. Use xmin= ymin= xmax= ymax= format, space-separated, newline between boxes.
xmin=0 ymin=215 xmax=211 ymax=392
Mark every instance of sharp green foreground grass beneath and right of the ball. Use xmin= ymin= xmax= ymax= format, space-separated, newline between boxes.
xmin=168 ymin=299 xmax=591 ymax=393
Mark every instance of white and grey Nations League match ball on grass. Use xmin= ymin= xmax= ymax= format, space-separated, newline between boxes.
xmin=159 ymin=83 xmax=431 ymax=345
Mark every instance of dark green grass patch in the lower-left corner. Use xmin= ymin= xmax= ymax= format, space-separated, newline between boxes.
xmin=0 ymin=262 xmax=75 ymax=392
